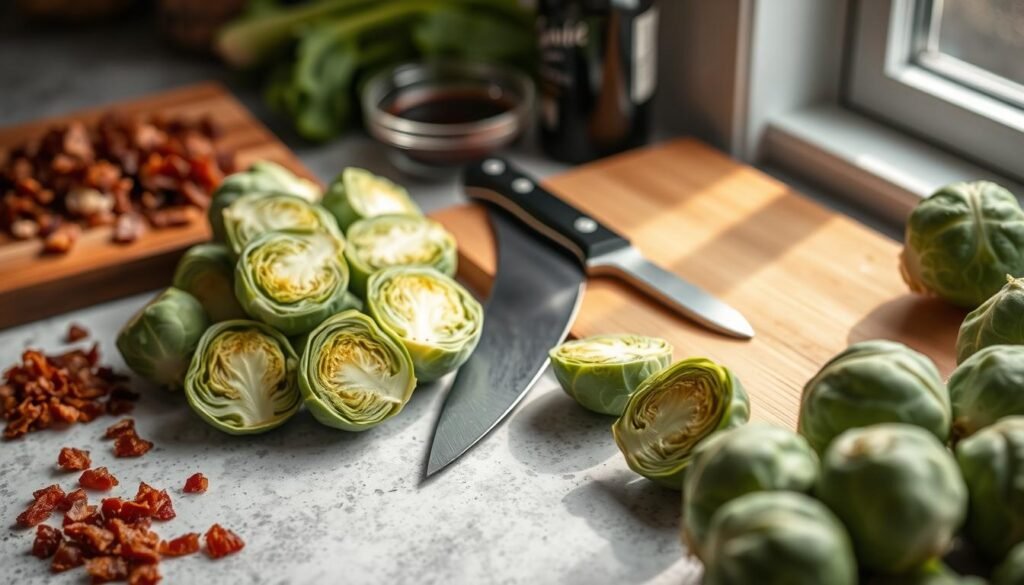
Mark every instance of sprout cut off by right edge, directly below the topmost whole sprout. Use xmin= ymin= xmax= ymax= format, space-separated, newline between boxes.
xmin=956 ymin=276 xmax=1024 ymax=364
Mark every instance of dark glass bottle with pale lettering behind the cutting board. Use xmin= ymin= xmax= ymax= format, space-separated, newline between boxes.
xmin=538 ymin=0 xmax=657 ymax=163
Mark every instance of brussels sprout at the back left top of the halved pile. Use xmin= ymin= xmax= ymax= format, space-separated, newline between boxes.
xmin=207 ymin=161 xmax=323 ymax=242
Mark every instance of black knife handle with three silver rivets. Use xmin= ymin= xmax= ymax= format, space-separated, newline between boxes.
xmin=463 ymin=157 xmax=630 ymax=263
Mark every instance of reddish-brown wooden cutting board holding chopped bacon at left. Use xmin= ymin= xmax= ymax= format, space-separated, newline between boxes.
xmin=0 ymin=83 xmax=314 ymax=329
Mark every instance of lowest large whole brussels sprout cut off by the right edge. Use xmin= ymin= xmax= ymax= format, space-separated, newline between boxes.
xmin=956 ymin=416 xmax=1024 ymax=559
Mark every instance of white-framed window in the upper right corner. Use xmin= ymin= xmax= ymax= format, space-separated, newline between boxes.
xmin=845 ymin=0 xmax=1024 ymax=178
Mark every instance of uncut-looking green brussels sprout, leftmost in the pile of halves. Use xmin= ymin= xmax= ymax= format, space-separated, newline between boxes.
xmin=117 ymin=287 xmax=210 ymax=389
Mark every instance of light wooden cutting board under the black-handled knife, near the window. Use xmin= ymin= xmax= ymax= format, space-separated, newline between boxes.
xmin=433 ymin=139 xmax=964 ymax=427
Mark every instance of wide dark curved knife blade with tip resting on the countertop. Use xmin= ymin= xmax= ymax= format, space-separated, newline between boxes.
xmin=427 ymin=209 xmax=586 ymax=476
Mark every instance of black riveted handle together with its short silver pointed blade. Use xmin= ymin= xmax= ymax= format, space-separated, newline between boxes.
xmin=464 ymin=158 xmax=754 ymax=339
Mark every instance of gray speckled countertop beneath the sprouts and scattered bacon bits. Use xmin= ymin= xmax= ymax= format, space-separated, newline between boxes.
xmin=0 ymin=8 xmax=699 ymax=584
